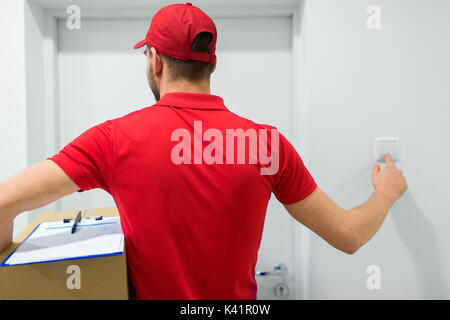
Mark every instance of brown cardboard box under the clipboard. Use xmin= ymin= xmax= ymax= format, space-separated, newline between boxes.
xmin=0 ymin=208 xmax=128 ymax=299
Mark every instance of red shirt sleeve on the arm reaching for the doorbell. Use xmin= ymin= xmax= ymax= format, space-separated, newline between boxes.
xmin=273 ymin=133 xmax=317 ymax=204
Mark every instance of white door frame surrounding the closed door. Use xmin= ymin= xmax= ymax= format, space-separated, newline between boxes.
xmin=28 ymin=0 xmax=311 ymax=299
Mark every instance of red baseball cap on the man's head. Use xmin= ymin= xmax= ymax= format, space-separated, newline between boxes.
xmin=134 ymin=2 xmax=217 ymax=63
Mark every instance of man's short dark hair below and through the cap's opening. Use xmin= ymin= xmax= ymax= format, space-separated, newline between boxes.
xmin=149 ymin=32 xmax=213 ymax=82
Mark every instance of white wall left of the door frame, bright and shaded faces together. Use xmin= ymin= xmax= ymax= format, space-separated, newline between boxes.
xmin=0 ymin=0 xmax=56 ymax=236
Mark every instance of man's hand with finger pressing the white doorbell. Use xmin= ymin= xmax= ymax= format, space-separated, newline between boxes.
xmin=372 ymin=154 xmax=408 ymax=204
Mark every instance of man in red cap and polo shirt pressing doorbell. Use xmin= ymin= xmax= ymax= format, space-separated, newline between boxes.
xmin=0 ymin=3 xmax=407 ymax=299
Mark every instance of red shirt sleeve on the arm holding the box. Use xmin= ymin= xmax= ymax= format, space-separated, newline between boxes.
xmin=47 ymin=120 xmax=113 ymax=193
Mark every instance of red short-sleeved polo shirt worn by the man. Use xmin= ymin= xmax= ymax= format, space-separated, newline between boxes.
xmin=48 ymin=93 xmax=316 ymax=299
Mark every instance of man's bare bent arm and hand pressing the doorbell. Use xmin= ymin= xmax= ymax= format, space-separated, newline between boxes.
xmin=285 ymin=155 xmax=407 ymax=254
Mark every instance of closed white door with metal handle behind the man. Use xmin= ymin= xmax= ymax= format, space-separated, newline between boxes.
xmin=58 ymin=17 xmax=300 ymax=299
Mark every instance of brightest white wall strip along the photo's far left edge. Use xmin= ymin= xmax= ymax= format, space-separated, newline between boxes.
xmin=0 ymin=0 xmax=27 ymax=238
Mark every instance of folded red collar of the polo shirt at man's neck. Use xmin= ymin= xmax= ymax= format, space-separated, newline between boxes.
xmin=155 ymin=92 xmax=228 ymax=111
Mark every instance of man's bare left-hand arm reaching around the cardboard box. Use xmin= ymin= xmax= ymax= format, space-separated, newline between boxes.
xmin=0 ymin=160 xmax=80 ymax=251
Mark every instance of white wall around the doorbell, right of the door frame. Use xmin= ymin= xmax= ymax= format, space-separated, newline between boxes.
xmin=302 ymin=0 xmax=450 ymax=299
